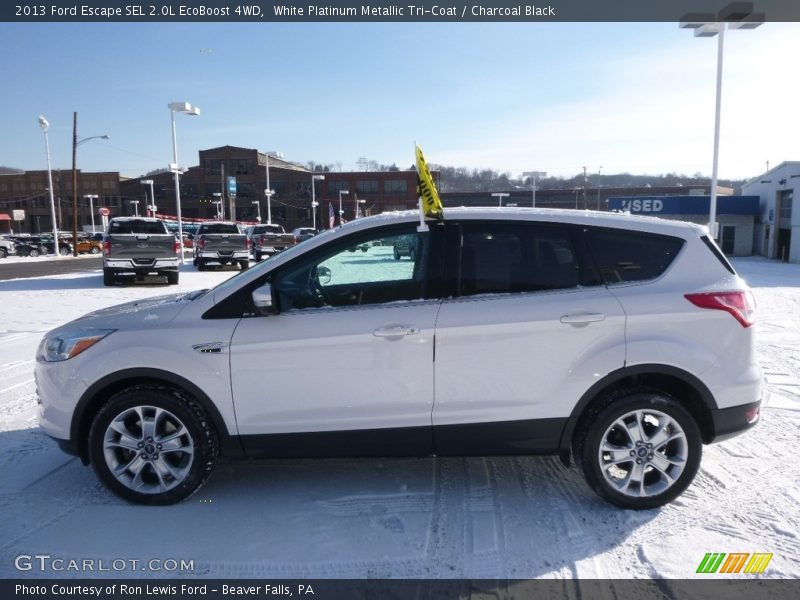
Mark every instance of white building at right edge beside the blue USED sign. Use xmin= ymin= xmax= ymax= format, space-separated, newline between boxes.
xmin=742 ymin=161 xmax=800 ymax=262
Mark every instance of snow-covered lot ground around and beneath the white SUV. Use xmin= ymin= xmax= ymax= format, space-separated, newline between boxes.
xmin=0 ymin=253 xmax=800 ymax=578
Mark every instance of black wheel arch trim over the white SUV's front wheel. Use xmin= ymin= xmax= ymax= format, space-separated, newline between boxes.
xmin=70 ymin=368 xmax=243 ymax=465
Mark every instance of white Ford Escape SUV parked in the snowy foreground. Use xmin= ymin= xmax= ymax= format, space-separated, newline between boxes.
xmin=36 ymin=209 xmax=762 ymax=509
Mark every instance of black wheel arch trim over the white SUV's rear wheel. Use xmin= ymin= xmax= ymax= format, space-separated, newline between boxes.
xmin=559 ymin=364 xmax=718 ymax=465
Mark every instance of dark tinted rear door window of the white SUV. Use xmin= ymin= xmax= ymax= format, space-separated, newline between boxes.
xmin=460 ymin=222 xmax=580 ymax=296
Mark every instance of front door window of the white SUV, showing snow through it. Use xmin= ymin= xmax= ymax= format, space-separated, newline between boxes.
xmin=274 ymin=227 xmax=430 ymax=311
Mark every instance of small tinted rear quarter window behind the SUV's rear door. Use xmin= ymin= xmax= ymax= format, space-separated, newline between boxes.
xmin=588 ymin=227 xmax=684 ymax=284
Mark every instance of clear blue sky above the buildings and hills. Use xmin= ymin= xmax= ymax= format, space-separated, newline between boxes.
xmin=0 ymin=23 xmax=800 ymax=177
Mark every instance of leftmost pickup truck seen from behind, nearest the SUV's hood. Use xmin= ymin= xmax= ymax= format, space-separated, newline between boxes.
xmin=103 ymin=217 xmax=180 ymax=285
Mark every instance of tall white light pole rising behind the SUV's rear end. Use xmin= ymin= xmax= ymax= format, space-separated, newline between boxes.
xmin=680 ymin=2 xmax=764 ymax=239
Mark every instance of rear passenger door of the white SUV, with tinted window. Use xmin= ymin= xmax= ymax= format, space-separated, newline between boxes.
xmin=433 ymin=221 xmax=625 ymax=454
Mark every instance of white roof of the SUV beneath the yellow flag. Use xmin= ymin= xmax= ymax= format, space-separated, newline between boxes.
xmin=340 ymin=206 xmax=708 ymax=237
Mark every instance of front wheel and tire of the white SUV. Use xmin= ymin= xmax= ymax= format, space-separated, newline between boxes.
xmin=89 ymin=385 xmax=219 ymax=505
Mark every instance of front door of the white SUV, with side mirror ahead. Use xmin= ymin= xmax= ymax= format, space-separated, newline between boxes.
xmin=230 ymin=224 xmax=439 ymax=456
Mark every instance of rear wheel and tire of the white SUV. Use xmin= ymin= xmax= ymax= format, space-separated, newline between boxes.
xmin=574 ymin=388 xmax=703 ymax=510
